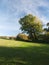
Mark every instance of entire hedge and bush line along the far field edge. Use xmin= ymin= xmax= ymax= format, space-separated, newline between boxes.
xmin=0 ymin=33 xmax=49 ymax=43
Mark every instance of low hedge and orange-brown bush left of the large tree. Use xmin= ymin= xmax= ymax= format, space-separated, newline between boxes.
xmin=0 ymin=33 xmax=29 ymax=40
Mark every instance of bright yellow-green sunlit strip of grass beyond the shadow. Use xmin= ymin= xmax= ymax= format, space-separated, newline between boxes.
xmin=0 ymin=39 xmax=46 ymax=47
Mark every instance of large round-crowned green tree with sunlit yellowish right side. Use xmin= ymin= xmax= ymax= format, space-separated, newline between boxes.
xmin=19 ymin=14 xmax=42 ymax=39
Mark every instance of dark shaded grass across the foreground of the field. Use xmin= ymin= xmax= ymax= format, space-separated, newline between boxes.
xmin=0 ymin=46 xmax=49 ymax=65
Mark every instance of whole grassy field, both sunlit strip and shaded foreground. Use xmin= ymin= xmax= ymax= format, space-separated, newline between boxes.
xmin=0 ymin=39 xmax=49 ymax=65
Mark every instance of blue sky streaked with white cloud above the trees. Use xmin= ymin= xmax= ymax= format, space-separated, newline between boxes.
xmin=0 ymin=0 xmax=49 ymax=36
